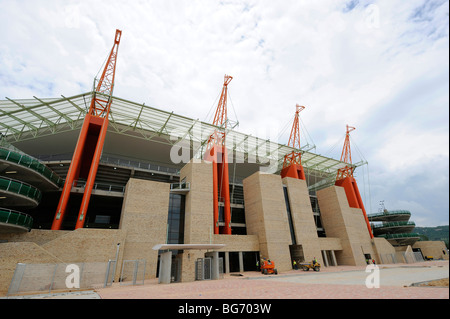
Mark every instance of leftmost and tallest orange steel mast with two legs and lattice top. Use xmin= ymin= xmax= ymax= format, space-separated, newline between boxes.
xmin=51 ymin=30 xmax=122 ymax=230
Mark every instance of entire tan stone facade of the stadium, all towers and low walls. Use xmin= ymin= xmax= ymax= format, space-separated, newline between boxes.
xmin=0 ymin=160 xmax=442 ymax=295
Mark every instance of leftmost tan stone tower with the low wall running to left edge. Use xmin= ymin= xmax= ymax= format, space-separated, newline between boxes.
xmin=0 ymin=178 xmax=170 ymax=293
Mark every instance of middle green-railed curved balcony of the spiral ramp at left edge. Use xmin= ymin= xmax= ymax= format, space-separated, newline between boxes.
xmin=0 ymin=176 xmax=42 ymax=208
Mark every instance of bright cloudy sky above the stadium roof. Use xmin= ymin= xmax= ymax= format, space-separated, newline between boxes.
xmin=0 ymin=0 xmax=449 ymax=226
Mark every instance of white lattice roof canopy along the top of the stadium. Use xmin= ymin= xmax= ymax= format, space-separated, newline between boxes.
xmin=0 ymin=92 xmax=365 ymax=189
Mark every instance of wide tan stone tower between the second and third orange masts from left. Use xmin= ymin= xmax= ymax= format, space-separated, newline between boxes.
xmin=244 ymin=172 xmax=292 ymax=271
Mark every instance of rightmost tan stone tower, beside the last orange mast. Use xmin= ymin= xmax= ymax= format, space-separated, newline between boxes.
xmin=317 ymin=186 xmax=375 ymax=266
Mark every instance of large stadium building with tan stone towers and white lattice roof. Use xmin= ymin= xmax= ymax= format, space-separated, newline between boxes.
xmin=0 ymin=30 xmax=448 ymax=292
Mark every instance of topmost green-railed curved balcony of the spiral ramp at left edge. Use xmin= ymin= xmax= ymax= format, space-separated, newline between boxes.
xmin=0 ymin=147 xmax=64 ymax=190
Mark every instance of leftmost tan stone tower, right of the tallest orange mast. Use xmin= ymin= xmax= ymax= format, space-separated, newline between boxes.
xmin=119 ymin=178 xmax=170 ymax=278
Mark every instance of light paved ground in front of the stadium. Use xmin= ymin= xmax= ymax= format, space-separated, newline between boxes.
xmin=5 ymin=261 xmax=449 ymax=299
